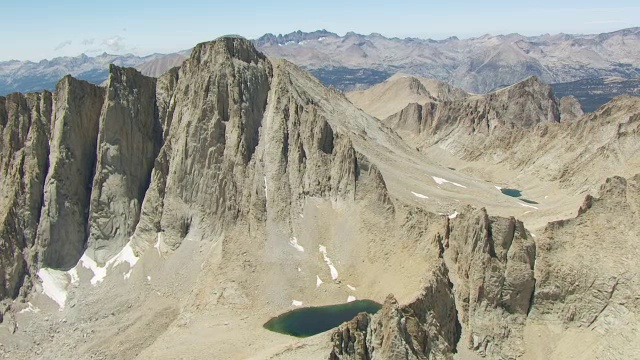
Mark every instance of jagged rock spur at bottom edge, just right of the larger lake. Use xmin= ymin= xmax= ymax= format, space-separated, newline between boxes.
xmin=329 ymin=263 xmax=460 ymax=360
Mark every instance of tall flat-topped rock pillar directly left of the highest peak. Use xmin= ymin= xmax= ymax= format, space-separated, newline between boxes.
xmin=88 ymin=66 xmax=162 ymax=262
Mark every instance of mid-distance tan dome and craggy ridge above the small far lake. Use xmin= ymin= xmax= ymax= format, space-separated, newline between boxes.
xmin=360 ymin=76 xmax=560 ymax=146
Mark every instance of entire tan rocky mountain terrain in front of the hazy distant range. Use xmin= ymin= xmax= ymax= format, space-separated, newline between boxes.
xmin=0 ymin=32 xmax=640 ymax=360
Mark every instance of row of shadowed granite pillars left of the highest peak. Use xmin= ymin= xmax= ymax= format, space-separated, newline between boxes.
xmin=0 ymin=66 xmax=160 ymax=306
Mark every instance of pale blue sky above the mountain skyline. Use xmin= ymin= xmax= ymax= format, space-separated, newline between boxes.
xmin=0 ymin=0 xmax=640 ymax=60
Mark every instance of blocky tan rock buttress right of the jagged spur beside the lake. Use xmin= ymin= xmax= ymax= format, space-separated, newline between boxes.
xmin=445 ymin=208 xmax=536 ymax=357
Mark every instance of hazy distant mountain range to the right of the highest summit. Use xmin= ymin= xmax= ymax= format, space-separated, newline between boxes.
xmin=255 ymin=28 xmax=640 ymax=93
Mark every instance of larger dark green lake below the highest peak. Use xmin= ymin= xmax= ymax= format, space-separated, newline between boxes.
xmin=264 ymin=300 xmax=382 ymax=337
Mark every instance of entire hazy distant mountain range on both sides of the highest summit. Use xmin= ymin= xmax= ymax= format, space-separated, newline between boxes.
xmin=0 ymin=27 xmax=640 ymax=111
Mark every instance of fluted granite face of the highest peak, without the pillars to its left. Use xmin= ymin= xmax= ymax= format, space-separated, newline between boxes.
xmin=135 ymin=37 xmax=386 ymax=249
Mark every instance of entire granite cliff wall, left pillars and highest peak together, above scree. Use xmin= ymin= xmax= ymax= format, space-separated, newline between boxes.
xmin=1 ymin=38 xmax=389 ymax=306
